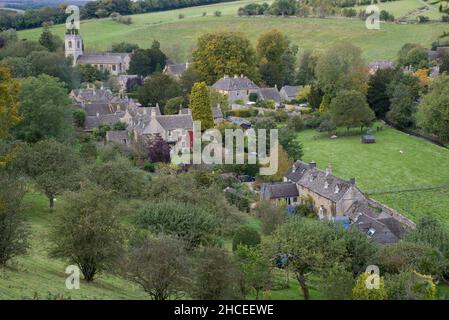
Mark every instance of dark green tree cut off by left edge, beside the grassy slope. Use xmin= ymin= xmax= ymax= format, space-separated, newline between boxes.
xmin=0 ymin=170 xmax=29 ymax=265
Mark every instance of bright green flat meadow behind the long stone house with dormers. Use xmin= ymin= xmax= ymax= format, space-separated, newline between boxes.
xmin=299 ymin=128 xmax=449 ymax=227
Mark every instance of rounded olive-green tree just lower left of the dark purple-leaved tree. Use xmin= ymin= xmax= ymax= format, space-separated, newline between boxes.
xmin=86 ymin=158 xmax=148 ymax=199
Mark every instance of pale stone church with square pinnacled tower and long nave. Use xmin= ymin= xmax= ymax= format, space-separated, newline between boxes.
xmin=64 ymin=29 xmax=131 ymax=75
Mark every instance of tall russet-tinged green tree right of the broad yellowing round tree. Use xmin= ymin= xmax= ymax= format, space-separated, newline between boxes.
xmin=257 ymin=30 xmax=297 ymax=87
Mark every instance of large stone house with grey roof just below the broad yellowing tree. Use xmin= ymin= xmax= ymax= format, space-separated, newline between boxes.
xmin=212 ymin=75 xmax=259 ymax=104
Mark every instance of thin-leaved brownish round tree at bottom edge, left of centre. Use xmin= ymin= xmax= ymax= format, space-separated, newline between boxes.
xmin=122 ymin=236 xmax=189 ymax=300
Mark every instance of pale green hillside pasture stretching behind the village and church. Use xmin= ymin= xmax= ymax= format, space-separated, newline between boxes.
xmin=19 ymin=0 xmax=448 ymax=61
